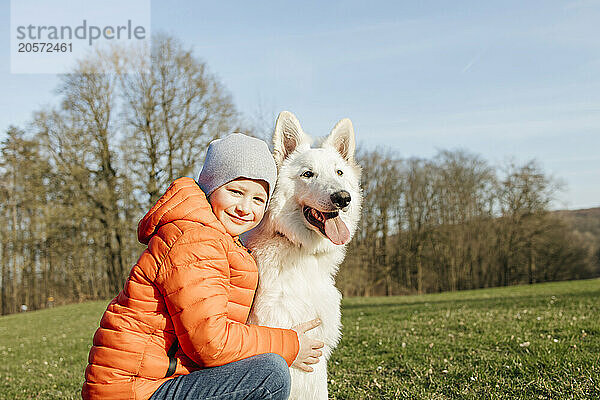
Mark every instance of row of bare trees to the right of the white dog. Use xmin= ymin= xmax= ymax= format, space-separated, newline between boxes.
xmin=338 ymin=150 xmax=600 ymax=296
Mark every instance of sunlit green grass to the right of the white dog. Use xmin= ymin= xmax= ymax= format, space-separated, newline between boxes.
xmin=329 ymin=280 xmax=600 ymax=399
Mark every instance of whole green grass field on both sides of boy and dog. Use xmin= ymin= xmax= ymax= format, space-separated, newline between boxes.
xmin=0 ymin=280 xmax=600 ymax=399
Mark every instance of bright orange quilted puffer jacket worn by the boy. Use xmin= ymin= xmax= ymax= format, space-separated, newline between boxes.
xmin=81 ymin=178 xmax=299 ymax=400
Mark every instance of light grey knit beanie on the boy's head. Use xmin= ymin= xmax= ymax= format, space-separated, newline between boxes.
xmin=198 ymin=133 xmax=277 ymax=202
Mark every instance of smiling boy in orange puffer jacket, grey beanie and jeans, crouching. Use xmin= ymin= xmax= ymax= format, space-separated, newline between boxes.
xmin=82 ymin=134 xmax=323 ymax=400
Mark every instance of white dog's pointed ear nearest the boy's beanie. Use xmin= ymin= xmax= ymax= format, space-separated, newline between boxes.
xmin=273 ymin=111 xmax=310 ymax=168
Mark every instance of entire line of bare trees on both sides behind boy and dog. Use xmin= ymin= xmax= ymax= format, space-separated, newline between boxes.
xmin=0 ymin=35 xmax=598 ymax=314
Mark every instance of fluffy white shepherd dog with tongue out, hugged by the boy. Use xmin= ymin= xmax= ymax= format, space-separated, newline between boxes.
xmin=243 ymin=111 xmax=362 ymax=400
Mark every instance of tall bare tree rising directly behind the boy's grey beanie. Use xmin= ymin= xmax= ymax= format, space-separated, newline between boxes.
xmin=120 ymin=35 xmax=238 ymax=208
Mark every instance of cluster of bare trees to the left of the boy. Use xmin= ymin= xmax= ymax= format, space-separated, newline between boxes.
xmin=0 ymin=35 xmax=241 ymax=314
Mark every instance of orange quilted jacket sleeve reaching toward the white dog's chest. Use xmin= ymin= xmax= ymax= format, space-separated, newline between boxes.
xmin=155 ymin=230 xmax=299 ymax=367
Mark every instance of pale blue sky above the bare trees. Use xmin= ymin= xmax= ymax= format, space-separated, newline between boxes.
xmin=0 ymin=0 xmax=600 ymax=209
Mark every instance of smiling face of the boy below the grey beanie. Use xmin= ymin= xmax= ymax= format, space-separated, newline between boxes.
xmin=208 ymin=178 xmax=268 ymax=237
